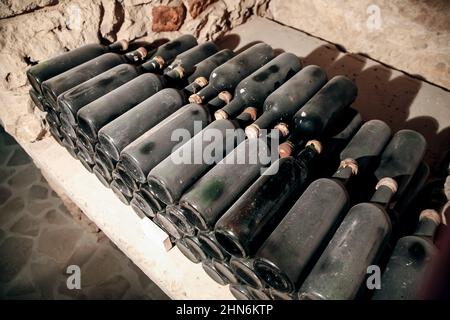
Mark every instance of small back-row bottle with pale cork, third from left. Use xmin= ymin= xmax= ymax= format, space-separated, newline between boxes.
xmin=184 ymin=49 xmax=234 ymax=94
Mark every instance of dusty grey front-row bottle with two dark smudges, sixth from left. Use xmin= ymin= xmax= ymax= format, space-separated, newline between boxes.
xmin=120 ymin=104 xmax=212 ymax=183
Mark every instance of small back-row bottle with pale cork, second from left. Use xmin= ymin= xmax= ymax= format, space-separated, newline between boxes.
xmin=164 ymin=41 xmax=219 ymax=79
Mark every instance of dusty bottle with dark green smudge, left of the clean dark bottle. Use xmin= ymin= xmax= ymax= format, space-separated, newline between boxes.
xmin=180 ymin=139 xmax=271 ymax=230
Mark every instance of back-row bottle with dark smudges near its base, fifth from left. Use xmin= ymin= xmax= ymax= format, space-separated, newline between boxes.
xmin=214 ymin=52 xmax=302 ymax=119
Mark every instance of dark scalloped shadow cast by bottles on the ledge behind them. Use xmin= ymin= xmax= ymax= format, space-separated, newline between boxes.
xmin=217 ymin=34 xmax=450 ymax=174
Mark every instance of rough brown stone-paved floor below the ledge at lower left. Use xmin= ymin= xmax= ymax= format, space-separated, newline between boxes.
xmin=0 ymin=126 xmax=168 ymax=299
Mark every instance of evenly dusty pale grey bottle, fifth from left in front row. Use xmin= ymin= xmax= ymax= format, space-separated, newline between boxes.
xmin=98 ymin=88 xmax=187 ymax=161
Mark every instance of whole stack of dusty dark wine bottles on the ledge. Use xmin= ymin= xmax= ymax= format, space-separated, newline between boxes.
xmin=27 ymin=35 xmax=440 ymax=299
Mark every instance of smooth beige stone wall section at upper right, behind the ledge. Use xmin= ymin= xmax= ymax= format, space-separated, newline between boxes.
xmin=267 ymin=0 xmax=450 ymax=89
